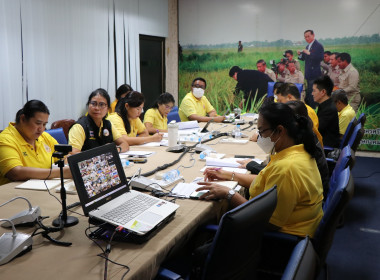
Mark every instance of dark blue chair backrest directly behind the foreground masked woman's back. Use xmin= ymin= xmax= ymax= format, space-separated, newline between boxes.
xmin=313 ymin=167 xmax=354 ymax=264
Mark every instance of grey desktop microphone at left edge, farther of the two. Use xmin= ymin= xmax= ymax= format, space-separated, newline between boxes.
xmin=0 ymin=196 xmax=41 ymax=228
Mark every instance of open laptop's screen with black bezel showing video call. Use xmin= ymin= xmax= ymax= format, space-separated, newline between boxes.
xmin=67 ymin=143 xmax=129 ymax=215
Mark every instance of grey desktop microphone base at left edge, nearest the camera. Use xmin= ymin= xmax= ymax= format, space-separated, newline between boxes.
xmin=0 ymin=219 xmax=33 ymax=265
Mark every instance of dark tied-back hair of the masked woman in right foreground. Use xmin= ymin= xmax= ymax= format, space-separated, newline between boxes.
xmin=260 ymin=102 xmax=316 ymax=158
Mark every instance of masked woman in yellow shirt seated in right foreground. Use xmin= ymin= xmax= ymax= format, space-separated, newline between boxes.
xmin=197 ymin=103 xmax=323 ymax=237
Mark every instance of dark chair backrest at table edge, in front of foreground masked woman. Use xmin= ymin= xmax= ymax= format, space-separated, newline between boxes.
xmin=202 ymin=186 xmax=277 ymax=279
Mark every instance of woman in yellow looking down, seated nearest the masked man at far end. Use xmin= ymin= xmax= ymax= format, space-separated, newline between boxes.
xmin=144 ymin=92 xmax=175 ymax=134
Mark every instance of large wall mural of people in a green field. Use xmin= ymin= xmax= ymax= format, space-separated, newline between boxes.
xmin=179 ymin=0 xmax=380 ymax=151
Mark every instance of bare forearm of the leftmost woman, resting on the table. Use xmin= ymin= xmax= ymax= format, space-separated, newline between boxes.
xmin=5 ymin=166 xmax=72 ymax=181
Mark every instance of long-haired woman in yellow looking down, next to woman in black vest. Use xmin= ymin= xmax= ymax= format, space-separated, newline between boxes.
xmin=108 ymin=91 xmax=162 ymax=145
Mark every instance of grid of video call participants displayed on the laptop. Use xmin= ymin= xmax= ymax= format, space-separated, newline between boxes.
xmin=78 ymin=152 xmax=121 ymax=198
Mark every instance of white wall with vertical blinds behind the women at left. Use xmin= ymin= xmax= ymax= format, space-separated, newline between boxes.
xmin=0 ymin=0 xmax=168 ymax=129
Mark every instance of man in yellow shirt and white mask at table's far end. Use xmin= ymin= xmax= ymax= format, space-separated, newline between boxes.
xmin=178 ymin=78 xmax=224 ymax=122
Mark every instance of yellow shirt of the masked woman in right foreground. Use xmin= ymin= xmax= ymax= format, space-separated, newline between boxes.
xmin=249 ymin=144 xmax=323 ymax=237
